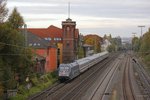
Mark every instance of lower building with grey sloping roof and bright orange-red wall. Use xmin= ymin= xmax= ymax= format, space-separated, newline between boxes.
xmin=23 ymin=31 xmax=57 ymax=73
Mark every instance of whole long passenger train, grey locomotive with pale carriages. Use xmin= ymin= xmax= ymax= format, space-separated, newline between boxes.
xmin=58 ymin=52 xmax=109 ymax=80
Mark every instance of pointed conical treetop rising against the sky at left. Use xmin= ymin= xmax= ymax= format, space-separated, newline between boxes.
xmin=8 ymin=8 xmax=24 ymax=29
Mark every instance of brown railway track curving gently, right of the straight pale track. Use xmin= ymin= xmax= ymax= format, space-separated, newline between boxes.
xmin=122 ymin=57 xmax=136 ymax=100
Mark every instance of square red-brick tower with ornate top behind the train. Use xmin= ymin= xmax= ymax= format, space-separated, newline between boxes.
xmin=62 ymin=18 xmax=77 ymax=63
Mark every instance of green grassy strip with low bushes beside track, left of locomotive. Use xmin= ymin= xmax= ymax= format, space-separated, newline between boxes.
xmin=10 ymin=72 xmax=58 ymax=100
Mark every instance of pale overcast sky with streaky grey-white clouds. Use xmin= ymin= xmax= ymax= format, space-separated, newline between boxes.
xmin=7 ymin=0 xmax=150 ymax=37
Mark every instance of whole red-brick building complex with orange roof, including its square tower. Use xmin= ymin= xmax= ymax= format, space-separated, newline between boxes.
xmin=22 ymin=19 xmax=79 ymax=72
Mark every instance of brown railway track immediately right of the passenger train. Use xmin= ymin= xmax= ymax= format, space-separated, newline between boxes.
xmin=48 ymin=52 xmax=117 ymax=100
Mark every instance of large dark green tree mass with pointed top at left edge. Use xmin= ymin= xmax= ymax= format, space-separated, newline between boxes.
xmin=0 ymin=5 xmax=32 ymax=94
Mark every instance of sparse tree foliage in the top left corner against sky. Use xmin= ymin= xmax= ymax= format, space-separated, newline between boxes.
xmin=0 ymin=0 xmax=8 ymax=23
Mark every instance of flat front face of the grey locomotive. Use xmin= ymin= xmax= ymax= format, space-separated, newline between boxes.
xmin=58 ymin=64 xmax=71 ymax=80
